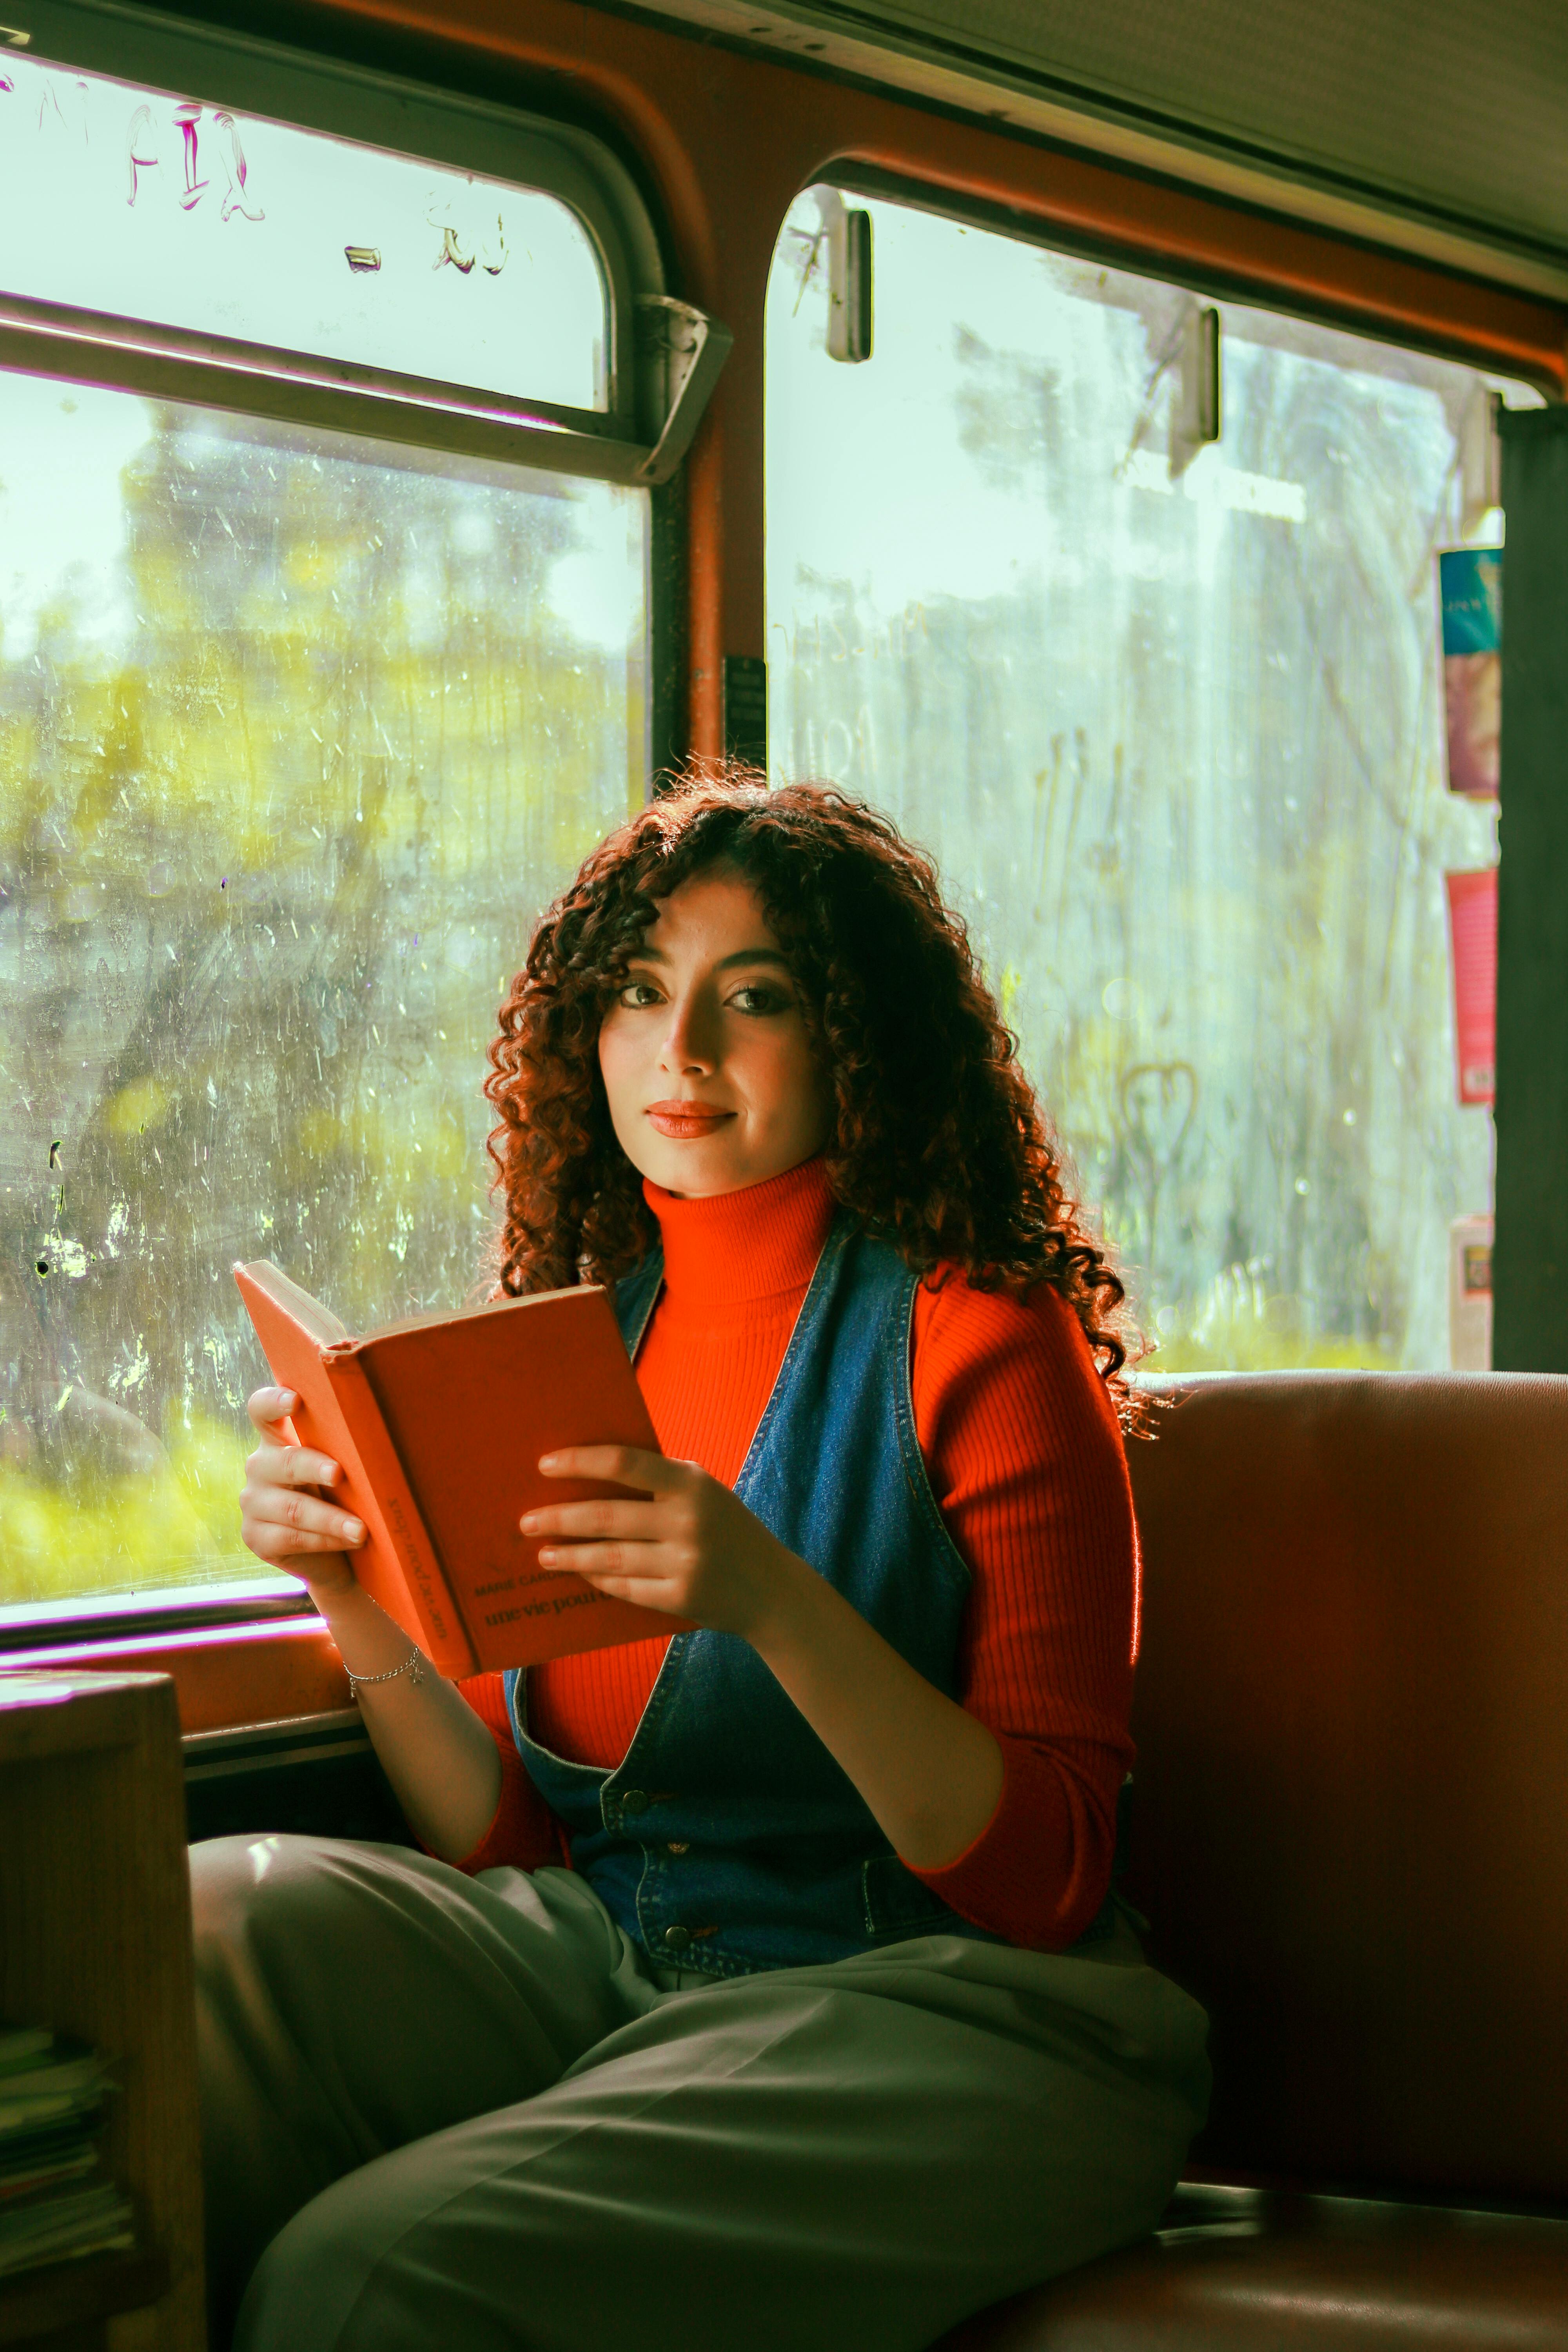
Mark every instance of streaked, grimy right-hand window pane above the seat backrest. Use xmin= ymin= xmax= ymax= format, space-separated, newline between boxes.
xmin=766 ymin=198 xmax=1533 ymax=1369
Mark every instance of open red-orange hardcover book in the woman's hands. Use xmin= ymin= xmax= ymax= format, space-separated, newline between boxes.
xmin=235 ymin=1258 xmax=682 ymax=1679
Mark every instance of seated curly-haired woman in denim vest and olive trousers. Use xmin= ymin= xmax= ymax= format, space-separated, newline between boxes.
xmin=193 ymin=781 xmax=1208 ymax=2352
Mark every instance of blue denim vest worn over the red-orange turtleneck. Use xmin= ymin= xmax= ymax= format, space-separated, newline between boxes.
xmin=505 ymin=1218 xmax=1006 ymax=1976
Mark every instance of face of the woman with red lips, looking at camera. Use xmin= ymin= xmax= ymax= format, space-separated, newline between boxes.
xmin=599 ymin=868 xmax=832 ymax=1197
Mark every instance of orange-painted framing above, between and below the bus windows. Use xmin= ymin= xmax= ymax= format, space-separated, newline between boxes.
xmin=19 ymin=0 xmax=1568 ymax=1731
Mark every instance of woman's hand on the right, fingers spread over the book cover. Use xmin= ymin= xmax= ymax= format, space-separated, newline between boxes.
xmin=519 ymin=1446 xmax=811 ymax=1644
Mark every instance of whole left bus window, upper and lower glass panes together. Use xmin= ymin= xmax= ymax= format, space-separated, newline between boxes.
xmin=0 ymin=27 xmax=649 ymax=1628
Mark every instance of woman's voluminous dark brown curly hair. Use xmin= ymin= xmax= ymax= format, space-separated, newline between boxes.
xmin=484 ymin=767 xmax=1129 ymax=1416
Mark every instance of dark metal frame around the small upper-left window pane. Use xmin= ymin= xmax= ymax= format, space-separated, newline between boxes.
xmin=0 ymin=0 xmax=729 ymax=487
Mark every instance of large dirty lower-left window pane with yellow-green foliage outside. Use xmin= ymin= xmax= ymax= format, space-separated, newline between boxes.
xmin=0 ymin=376 xmax=646 ymax=1602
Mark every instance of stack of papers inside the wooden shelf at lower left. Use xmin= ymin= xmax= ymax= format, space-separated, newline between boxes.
xmin=0 ymin=2025 xmax=134 ymax=2277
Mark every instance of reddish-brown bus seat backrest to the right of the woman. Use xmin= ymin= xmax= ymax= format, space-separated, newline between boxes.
xmin=1129 ymin=1374 xmax=1568 ymax=2201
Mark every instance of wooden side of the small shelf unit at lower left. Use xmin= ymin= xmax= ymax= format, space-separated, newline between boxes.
xmin=0 ymin=1672 xmax=205 ymax=2352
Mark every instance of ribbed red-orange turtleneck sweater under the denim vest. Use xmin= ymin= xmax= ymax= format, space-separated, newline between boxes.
xmin=463 ymin=1160 xmax=1138 ymax=1950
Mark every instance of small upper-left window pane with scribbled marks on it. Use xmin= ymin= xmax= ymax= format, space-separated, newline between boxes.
xmin=0 ymin=49 xmax=606 ymax=409
